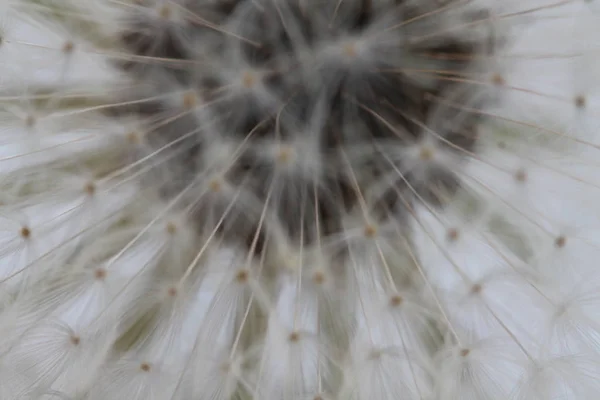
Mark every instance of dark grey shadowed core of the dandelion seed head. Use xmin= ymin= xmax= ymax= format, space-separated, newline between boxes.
xmin=110 ymin=0 xmax=494 ymax=254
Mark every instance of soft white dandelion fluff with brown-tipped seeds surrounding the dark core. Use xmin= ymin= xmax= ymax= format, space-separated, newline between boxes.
xmin=0 ymin=0 xmax=600 ymax=400
